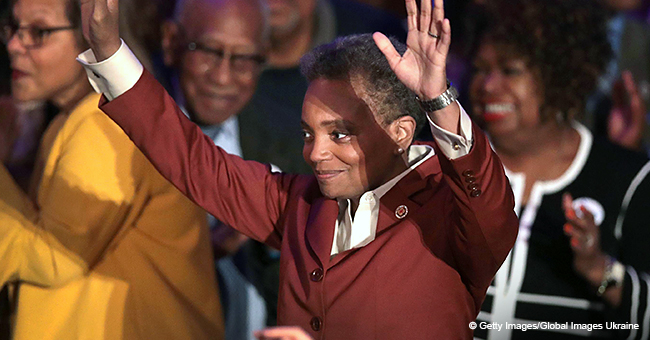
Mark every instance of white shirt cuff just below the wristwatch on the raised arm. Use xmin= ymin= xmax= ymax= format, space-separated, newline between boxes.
xmin=426 ymin=103 xmax=474 ymax=159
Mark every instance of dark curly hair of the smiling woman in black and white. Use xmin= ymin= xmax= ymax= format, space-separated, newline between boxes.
xmin=478 ymin=0 xmax=612 ymax=122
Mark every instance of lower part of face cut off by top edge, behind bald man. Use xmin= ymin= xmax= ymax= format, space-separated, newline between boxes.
xmin=266 ymin=0 xmax=316 ymax=38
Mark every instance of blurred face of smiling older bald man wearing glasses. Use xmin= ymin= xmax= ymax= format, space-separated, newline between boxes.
xmin=167 ymin=1 xmax=265 ymax=125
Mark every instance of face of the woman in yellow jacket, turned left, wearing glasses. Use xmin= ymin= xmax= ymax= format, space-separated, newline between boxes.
xmin=7 ymin=0 xmax=89 ymax=103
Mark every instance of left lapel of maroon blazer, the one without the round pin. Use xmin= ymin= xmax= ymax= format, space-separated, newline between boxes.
xmin=305 ymin=197 xmax=339 ymax=267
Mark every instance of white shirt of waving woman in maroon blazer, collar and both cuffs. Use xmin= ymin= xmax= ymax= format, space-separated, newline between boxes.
xmin=77 ymin=41 xmax=473 ymax=255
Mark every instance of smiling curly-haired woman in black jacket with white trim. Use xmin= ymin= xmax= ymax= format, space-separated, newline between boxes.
xmin=470 ymin=0 xmax=650 ymax=339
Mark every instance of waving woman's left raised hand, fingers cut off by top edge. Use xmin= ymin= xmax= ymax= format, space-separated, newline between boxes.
xmin=80 ymin=0 xmax=121 ymax=61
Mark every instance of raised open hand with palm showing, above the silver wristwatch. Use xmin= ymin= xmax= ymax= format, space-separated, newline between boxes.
xmin=373 ymin=0 xmax=451 ymax=100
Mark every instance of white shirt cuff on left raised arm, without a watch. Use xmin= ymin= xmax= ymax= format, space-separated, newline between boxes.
xmin=77 ymin=40 xmax=144 ymax=101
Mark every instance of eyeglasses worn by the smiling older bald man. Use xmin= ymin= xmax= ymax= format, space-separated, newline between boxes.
xmin=187 ymin=42 xmax=266 ymax=76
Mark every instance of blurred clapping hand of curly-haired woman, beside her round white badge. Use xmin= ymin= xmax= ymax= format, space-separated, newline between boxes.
xmin=562 ymin=193 xmax=607 ymax=286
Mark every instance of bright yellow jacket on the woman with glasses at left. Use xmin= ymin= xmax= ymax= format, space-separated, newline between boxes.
xmin=0 ymin=94 xmax=224 ymax=340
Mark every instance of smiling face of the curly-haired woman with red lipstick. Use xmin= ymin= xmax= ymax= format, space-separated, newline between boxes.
xmin=470 ymin=43 xmax=542 ymax=138
